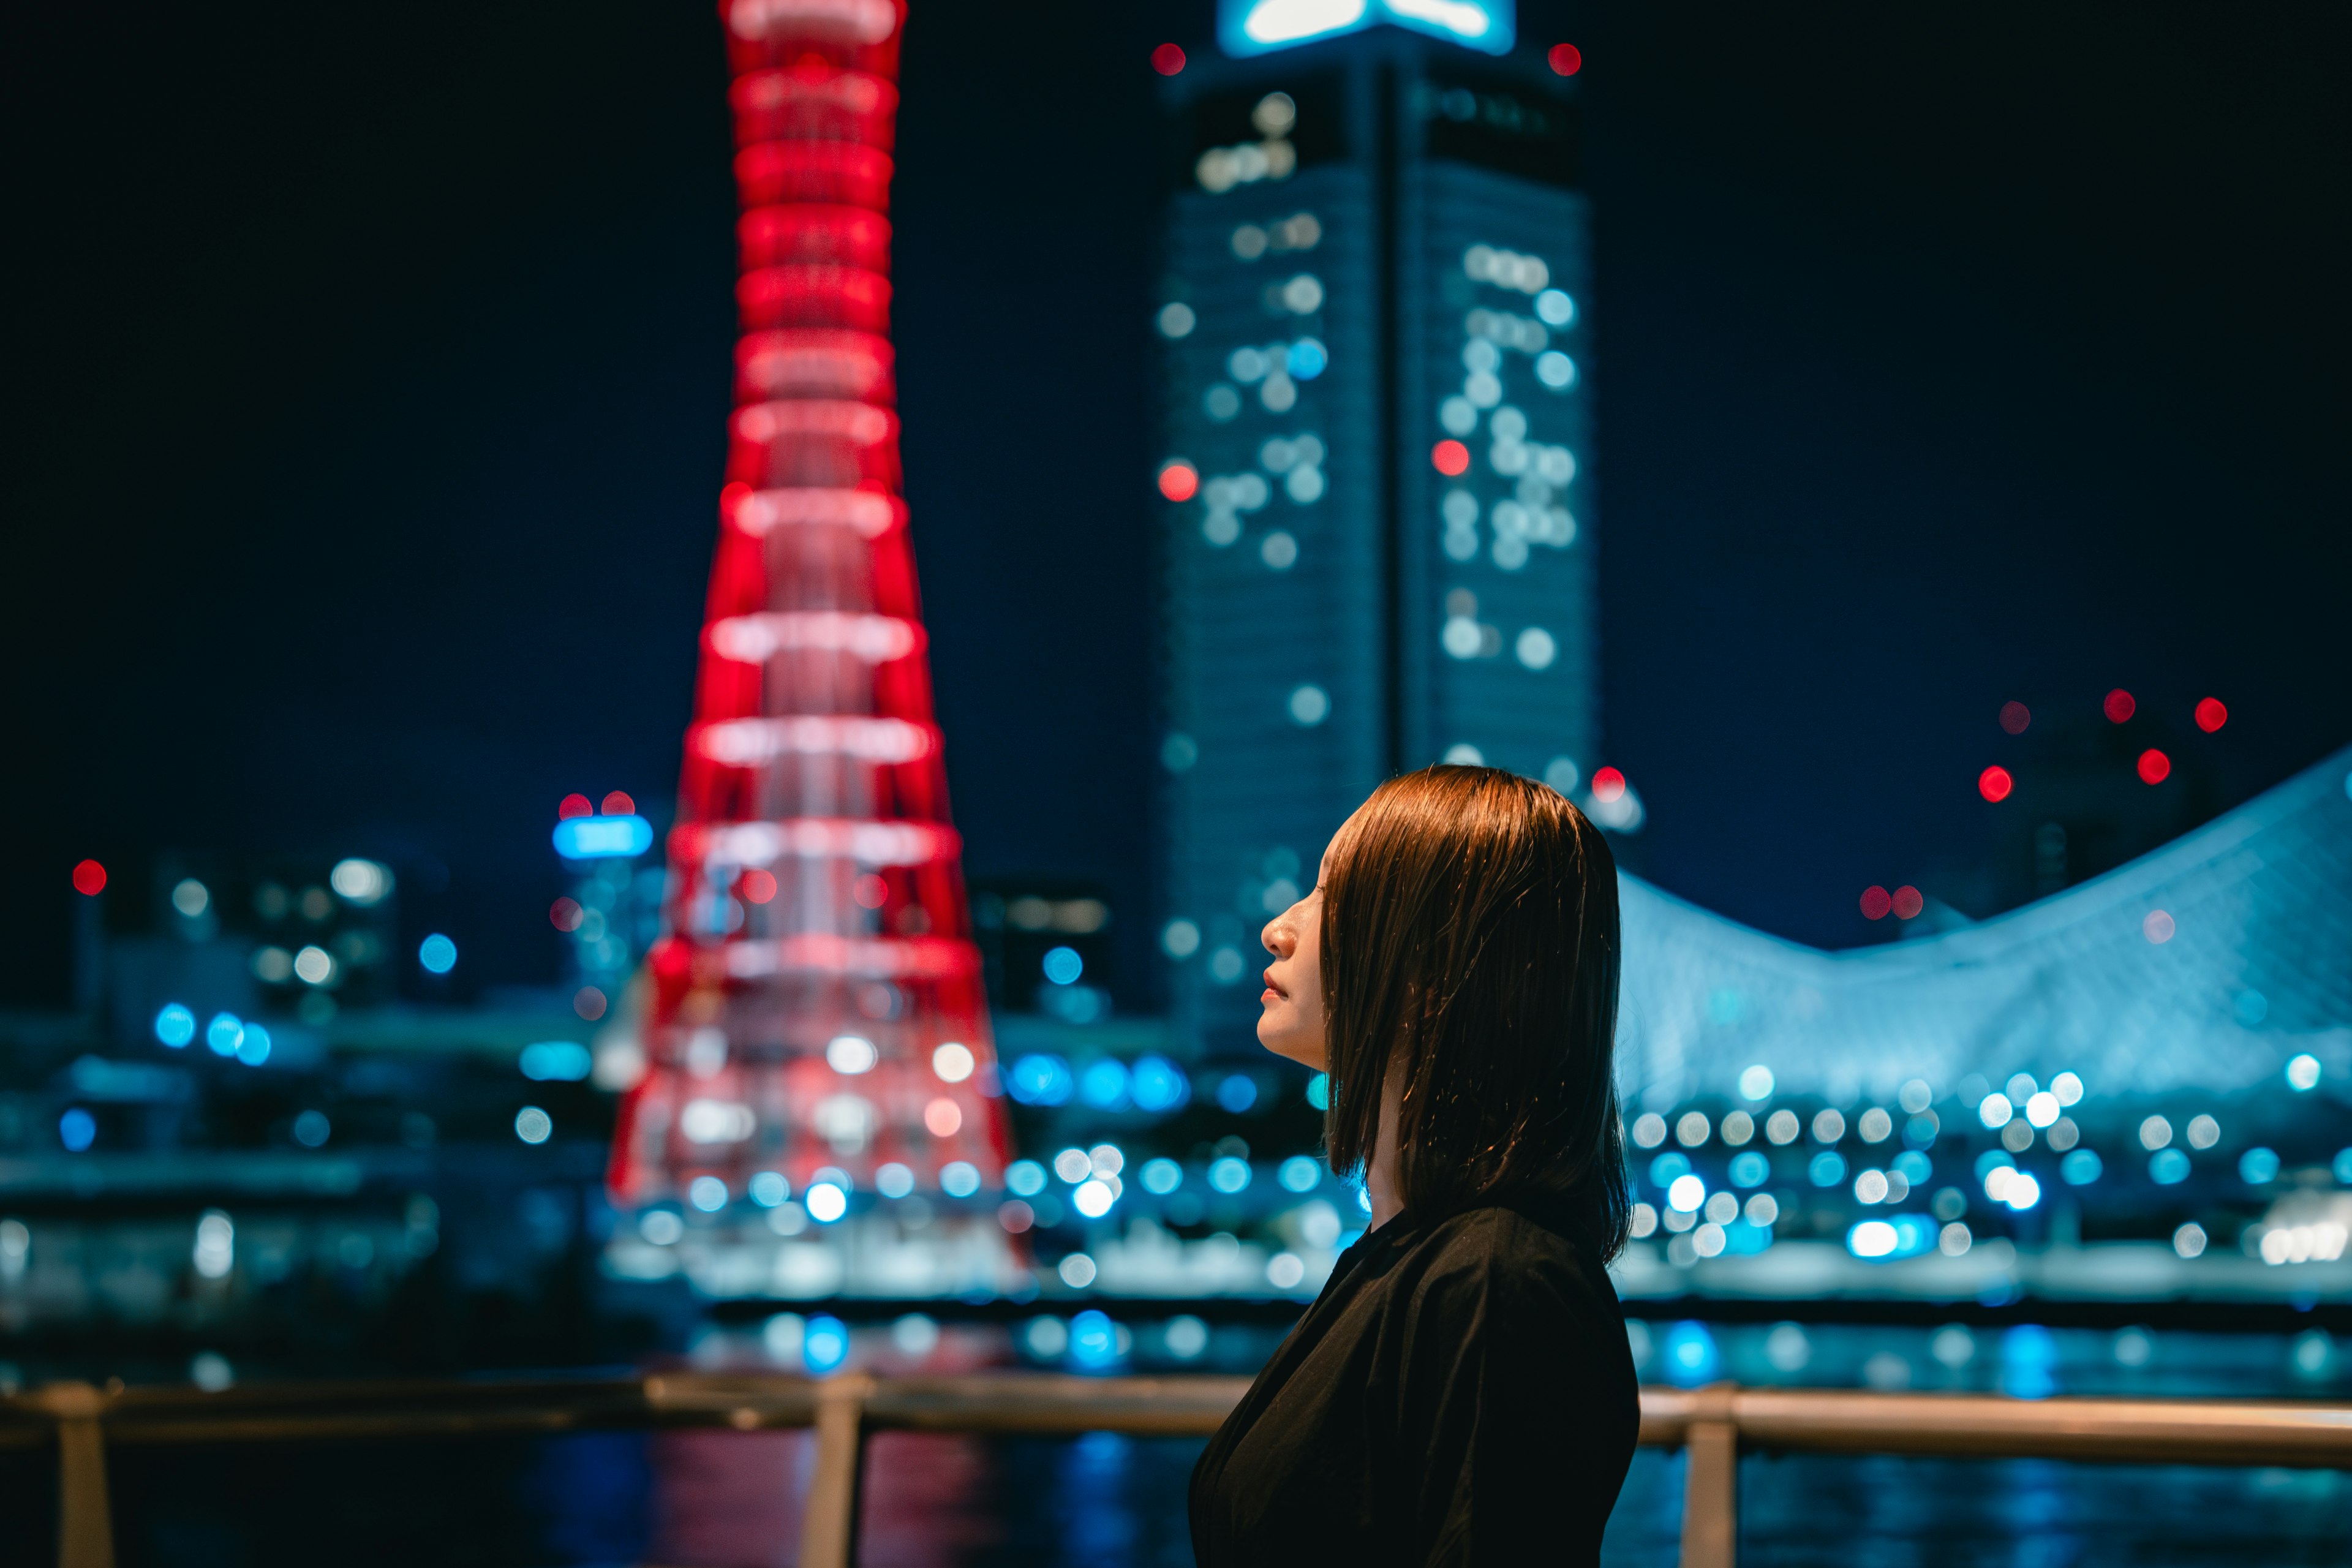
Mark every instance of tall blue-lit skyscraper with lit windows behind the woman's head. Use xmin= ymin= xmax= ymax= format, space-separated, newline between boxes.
xmin=1157 ymin=18 xmax=1618 ymax=1051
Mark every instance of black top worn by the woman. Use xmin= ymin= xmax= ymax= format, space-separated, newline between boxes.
xmin=1190 ymin=1197 xmax=1642 ymax=1568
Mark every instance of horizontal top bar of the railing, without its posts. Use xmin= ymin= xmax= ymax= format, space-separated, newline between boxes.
xmin=0 ymin=1371 xmax=2352 ymax=1469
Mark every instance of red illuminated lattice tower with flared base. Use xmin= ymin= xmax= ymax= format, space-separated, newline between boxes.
xmin=611 ymin=0 xmax=1007 ymax=1251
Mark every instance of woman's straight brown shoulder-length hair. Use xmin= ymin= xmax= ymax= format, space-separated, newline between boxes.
xmin=1322 ymin=766 xmax=1630 ymax=1257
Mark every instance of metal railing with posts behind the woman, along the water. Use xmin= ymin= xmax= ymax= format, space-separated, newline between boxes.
xmin=0 ymin=1373 xmax=2352 ymax=1568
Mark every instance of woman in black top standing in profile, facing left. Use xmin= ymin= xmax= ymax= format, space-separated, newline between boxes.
xmin=1193 ymin=766 xmax=1642 ymax=1568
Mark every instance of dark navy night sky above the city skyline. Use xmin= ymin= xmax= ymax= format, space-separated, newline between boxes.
xmin=0 ymin=0 xmax=2352 ymax=1006
